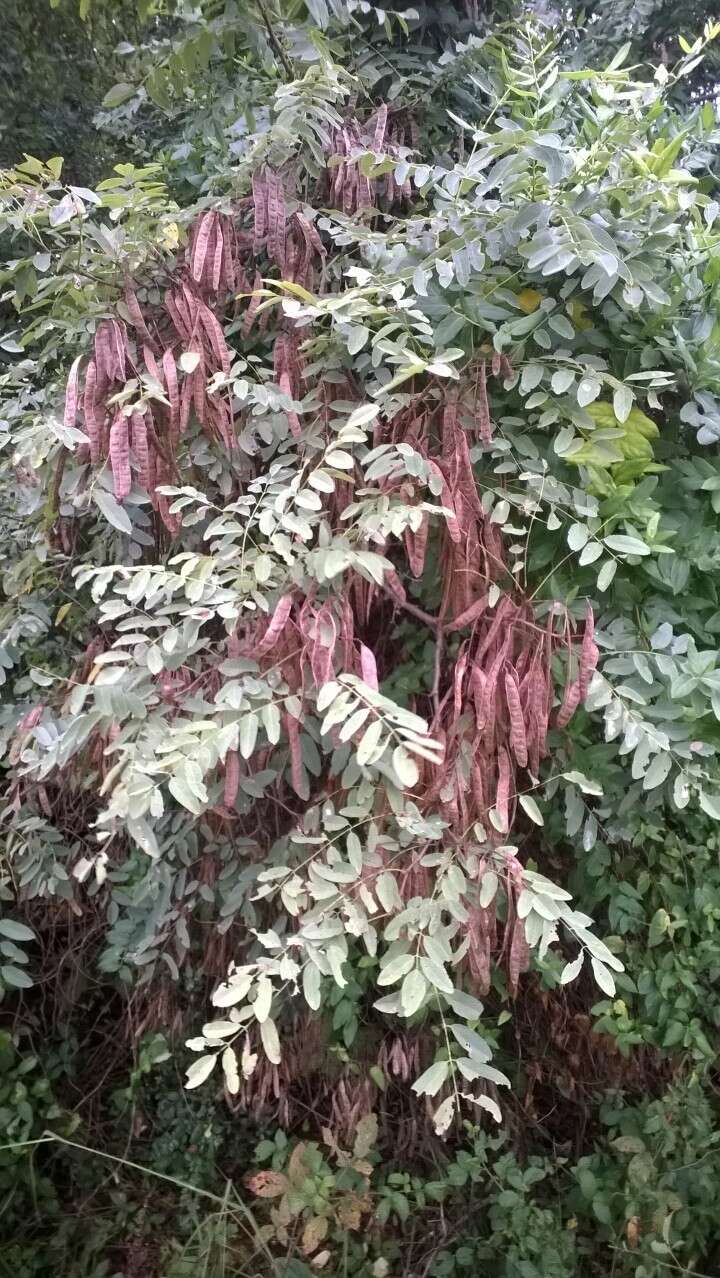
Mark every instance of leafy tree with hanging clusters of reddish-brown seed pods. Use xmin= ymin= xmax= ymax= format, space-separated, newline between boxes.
xmin=0 ymin=0 xmax=720 ymax=1267
